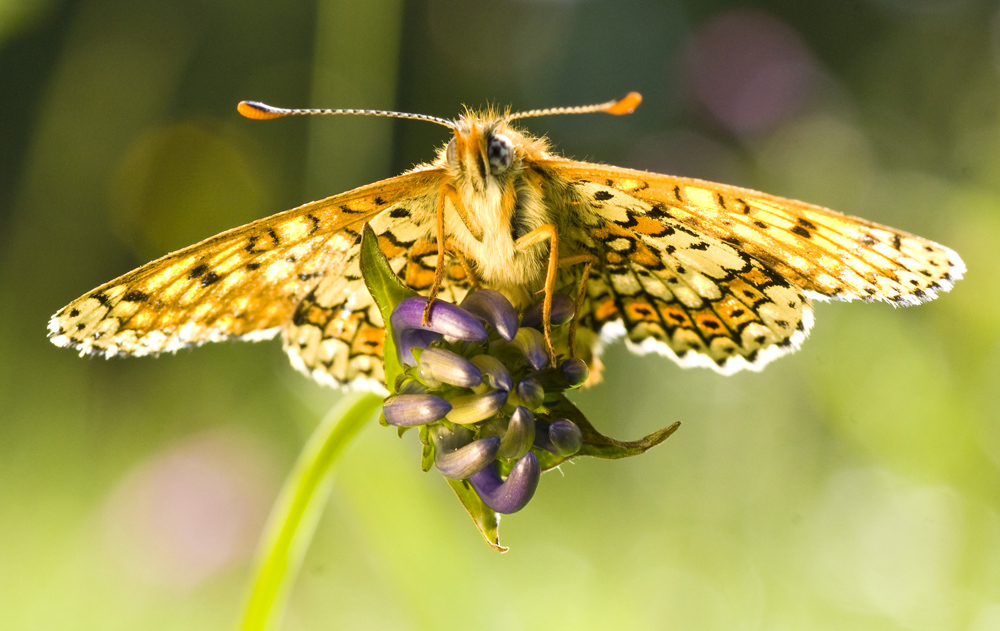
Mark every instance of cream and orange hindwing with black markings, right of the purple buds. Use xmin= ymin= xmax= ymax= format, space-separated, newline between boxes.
xmin=569 ymin=175 xmax=812 ymax=374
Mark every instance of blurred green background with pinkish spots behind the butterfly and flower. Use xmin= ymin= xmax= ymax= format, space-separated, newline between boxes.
xmin=0 ymin=0 xmax=1000 ymax=631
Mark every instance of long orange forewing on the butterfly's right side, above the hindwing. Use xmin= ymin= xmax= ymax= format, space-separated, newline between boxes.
xmin=560 ymin=163 xmax=965 ymax=304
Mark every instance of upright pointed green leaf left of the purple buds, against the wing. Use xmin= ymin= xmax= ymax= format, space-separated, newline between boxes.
xmin=361 ymin=224 xmax=417 ymax=393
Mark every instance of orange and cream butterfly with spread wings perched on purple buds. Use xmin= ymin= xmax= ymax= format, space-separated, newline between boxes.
xmin=49 ymin=92 xmax=965 ymax=385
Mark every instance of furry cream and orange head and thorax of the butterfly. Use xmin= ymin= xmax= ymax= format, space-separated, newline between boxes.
xmin=438 ymin=115 xmax=553 ymax=306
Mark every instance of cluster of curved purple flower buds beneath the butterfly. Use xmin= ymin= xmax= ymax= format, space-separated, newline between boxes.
xmin=383 ymin=289 xmax=588 ymax=513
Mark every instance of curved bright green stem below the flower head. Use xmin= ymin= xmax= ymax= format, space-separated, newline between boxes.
xmin=240 ymin=393 xmax=382 ymax=631
